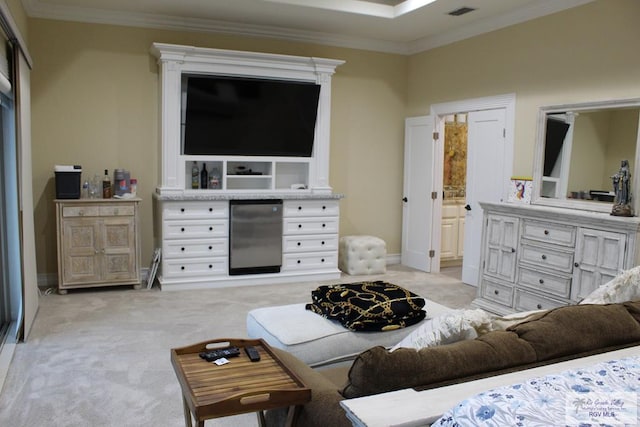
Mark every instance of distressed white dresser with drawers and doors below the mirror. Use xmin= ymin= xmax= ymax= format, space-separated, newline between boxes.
xmin=473 ymin=203 xmax=640 ymax=314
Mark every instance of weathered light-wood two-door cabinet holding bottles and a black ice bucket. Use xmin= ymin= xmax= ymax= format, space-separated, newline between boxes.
xmin=55 ymin=199 xmax=140 ymax=294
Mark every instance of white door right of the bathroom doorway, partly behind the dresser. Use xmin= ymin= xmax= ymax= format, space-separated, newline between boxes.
xmin=462 ymin=108 xmax=509 ymax=286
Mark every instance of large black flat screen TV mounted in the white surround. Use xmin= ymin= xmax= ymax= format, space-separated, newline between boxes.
xmin=182 ymin=75 xmax=320 ymax=157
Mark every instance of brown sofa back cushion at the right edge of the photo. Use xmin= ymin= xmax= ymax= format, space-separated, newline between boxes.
xmin=507 ymin=304 xmax=640 ymax=361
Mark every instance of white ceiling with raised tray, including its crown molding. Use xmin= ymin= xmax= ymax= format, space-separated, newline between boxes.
xmin=22 ymin=0 xmax=593 ymax=54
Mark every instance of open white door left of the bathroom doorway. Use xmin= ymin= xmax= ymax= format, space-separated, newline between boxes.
xmin=400 ymin=116 xmax=434 ymax=272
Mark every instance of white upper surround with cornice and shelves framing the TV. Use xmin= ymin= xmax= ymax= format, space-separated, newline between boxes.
xmin=151 ymin=43 xmax=344 ymax=195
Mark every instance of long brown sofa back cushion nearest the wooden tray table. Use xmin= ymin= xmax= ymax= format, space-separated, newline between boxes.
xmin=342 ymin=331 xmax=536 ymax=398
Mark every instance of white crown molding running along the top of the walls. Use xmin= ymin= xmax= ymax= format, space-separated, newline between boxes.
xmin=21 ymin=0 xmax=594 ymax=55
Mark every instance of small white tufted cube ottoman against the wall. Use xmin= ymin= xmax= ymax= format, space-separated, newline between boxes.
xmin=338 ymin=236 xmax=387 ymax=275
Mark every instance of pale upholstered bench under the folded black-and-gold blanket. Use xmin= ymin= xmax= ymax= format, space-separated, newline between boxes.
xmin=247 ymin=300 xmax=452 ymax=367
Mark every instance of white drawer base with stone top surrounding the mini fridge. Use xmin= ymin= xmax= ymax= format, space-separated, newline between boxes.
xmin=154 ymin=194 xmax=341 ymax=290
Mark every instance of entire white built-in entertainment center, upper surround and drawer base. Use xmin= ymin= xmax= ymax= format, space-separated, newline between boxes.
xmin=151 ymin=43 xmax=343 ymax=290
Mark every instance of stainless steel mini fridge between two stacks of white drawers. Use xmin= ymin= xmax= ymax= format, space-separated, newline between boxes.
xmin=229 ymin=200 xmax=282 ymax=275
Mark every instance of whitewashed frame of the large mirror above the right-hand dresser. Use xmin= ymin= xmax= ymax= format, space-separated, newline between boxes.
xmin=531 ymin=98 xmax=640 ymax=216
